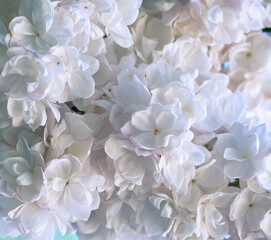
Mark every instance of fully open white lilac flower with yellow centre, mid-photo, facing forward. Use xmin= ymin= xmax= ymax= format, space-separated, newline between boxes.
xmin=121 ymin=104 xmax=187 ymax=153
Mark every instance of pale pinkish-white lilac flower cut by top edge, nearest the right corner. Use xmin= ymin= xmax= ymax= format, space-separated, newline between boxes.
xmin=206 ymin=0 xmax=265 ymax=43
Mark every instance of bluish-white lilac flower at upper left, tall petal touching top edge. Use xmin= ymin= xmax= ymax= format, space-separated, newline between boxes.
xmin=9 ymin=0 xmax=71 ymax=51
